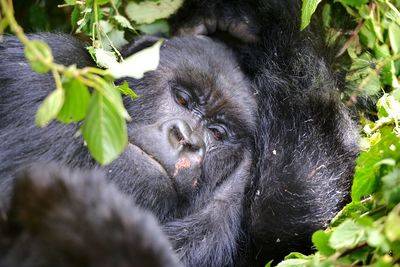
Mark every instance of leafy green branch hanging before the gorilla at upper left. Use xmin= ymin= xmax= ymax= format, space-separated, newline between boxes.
xmin=0 ymin=0 xmax=182 ymax=164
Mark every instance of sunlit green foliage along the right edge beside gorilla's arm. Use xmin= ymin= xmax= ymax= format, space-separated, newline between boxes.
xmin=278 ymin=0 xmax=400 ymax=267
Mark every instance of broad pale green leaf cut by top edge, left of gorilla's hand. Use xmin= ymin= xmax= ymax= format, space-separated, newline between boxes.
xmin=125 ymin=0 xmax=183 ymax=24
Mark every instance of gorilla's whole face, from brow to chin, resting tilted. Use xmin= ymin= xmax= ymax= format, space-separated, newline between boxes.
xmin=109 ymin=37 xmax=256 ymax=221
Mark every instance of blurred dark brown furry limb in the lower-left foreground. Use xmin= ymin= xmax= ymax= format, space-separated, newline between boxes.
xmin=0 ymin=165 xmax=178 ymax=267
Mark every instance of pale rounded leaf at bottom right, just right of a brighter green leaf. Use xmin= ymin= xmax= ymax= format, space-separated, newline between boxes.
xmin=329 ymin=220 xmax=365 ymax=250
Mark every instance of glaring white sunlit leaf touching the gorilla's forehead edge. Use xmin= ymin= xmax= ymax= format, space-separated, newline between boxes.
xmin=108 ymin=40 xmax=163 ymax=79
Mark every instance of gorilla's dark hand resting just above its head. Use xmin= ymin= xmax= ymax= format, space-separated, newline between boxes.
xmin=172 ymin=0 xmax=259 ymax=44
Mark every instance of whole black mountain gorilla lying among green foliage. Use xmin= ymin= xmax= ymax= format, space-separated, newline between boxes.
xmin=0 ymin=0 xmax=357 ymax=266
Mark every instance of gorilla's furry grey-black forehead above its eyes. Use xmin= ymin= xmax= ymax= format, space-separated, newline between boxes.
xmin=158 ymin=37 xmax=256 ymax=129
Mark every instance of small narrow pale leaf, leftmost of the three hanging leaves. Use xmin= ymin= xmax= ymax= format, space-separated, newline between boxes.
xmin=35 ymin=88 xmax=64 ymax=127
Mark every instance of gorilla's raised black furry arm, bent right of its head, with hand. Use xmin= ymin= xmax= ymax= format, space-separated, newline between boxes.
xmin=173 ymin=0 xmax=358 ymax=266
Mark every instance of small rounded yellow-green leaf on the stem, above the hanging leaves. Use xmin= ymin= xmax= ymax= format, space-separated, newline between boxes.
xmin=25 ymin=40 xmax=53 ymax=73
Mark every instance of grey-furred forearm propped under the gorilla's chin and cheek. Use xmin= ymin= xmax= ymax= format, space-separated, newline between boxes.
xmin=163 ymin=155 xmax=251 ymax=266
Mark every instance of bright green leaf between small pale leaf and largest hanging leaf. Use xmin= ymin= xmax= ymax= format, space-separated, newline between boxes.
xmin=57 ymin=79 xmax=90 ymax=123
